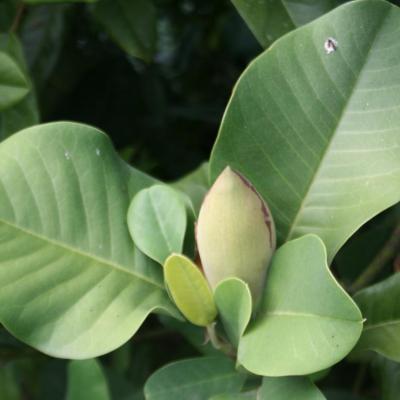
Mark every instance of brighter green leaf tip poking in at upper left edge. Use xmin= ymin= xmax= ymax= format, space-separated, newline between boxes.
xmin=0 ymin=51 xmax=29 ymax=110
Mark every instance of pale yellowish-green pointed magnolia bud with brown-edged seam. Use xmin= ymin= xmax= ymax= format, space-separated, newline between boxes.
xmin=196 ymin=167 xmax=276 ymax=303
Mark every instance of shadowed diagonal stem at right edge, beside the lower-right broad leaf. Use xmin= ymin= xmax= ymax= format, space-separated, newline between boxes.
xmin=350 ymin=222 xmax=400 ymax=293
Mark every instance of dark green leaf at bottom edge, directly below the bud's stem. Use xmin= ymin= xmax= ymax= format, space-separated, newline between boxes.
xmin=144 ymin=357 xmax=245 ymax=400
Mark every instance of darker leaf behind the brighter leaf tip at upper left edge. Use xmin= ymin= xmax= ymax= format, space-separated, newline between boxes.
xmin=0 ymin=34 xmax=39 ymax=140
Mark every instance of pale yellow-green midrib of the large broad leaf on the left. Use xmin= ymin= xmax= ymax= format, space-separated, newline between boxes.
xmin=0 ymin=218 xmax=164 ymax=289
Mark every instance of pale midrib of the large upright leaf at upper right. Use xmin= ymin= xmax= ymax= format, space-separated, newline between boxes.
xmin=284 ymin=7 xmax=392 ymax=242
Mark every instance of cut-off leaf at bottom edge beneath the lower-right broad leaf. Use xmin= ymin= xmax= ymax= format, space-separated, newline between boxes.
xmin=257 ymin=376 xmax=325 ymax=400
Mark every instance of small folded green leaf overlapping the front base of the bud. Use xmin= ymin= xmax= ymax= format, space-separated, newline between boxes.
xmin=214 ymin=278 xmax=252 ymax=347
